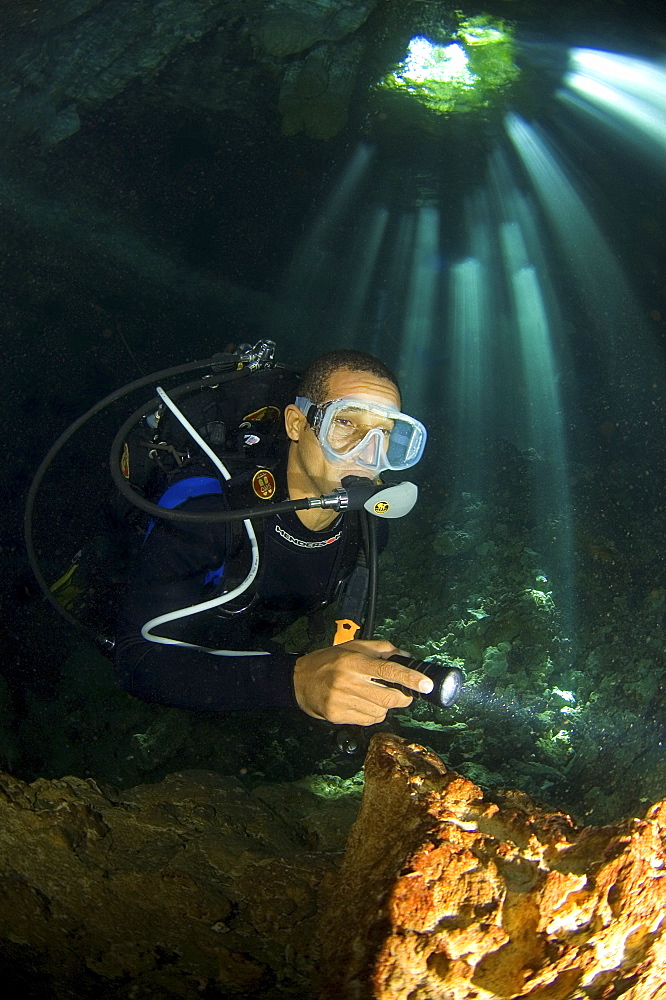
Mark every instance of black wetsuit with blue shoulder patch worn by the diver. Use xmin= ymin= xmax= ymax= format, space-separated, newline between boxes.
xmin=116 ymin=463 xmax=361 ymax=711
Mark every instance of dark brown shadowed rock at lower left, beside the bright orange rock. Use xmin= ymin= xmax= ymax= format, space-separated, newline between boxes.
xmin=0 ymin=771 xmax=356 ymax=1000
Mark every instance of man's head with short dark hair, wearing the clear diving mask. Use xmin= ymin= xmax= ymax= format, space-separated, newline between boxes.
xmin=285 ymin=350 xmax=426 ymax=496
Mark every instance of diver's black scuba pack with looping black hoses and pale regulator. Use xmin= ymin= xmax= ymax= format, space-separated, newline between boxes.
xmin=25 ymin=341 xmax=417 ymax=651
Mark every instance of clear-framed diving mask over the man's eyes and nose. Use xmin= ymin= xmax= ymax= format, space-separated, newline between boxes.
xmin=296 ymin=396 xmax=428 ymax=475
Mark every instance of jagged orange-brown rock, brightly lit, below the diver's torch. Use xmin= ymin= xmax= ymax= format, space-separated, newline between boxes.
xmin=321 ymin=733 xmax=666 ymax=1000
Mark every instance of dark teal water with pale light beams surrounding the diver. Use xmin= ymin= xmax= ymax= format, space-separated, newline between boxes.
xmin=0 ymin=0 xmax=666 ymax=821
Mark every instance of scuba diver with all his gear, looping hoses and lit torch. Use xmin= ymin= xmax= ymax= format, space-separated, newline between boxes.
xmin=24 ymin=340 xmax=463 ymax=728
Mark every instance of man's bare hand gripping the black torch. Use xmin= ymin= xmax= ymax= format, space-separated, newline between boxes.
xmin=294 ymin=639 xmax=432 ymax=726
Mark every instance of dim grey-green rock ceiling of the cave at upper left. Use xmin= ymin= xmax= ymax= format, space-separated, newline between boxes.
xmin=0 ymin=0 xmax=377 ymax=149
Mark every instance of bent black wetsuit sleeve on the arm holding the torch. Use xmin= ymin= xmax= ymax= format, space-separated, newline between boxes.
xmin=115 ymin=495 xmax=298 ymax=712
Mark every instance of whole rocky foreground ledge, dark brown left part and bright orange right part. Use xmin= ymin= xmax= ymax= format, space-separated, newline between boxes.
xmin=0 ymin=733 xmax=666 ymax=1000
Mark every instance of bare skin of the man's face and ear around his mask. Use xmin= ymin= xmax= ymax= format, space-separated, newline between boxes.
xmin=285 ymin=369 xmax=400 ymax=496
